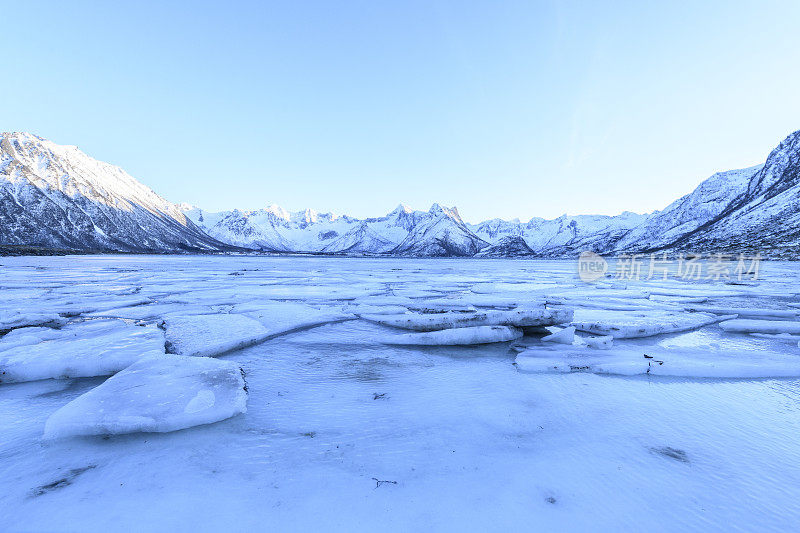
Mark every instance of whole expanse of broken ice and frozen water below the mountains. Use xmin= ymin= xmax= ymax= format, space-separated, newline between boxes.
xmin=0 ymin=255 xmax=800 ymax=532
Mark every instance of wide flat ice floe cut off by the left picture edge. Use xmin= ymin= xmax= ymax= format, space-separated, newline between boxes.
xmin=0 ymin=320 xmax=164 ymax=383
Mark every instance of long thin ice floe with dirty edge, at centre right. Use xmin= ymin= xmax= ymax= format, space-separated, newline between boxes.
xmin=362 ymin=307 xmax=572 ymax=331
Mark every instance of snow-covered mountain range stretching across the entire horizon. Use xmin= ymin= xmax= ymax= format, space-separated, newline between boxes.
xmin=0 ymin=127 xmax=800 ymax=258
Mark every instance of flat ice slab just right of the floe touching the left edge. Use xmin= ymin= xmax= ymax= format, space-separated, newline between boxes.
xmin=162 ymin=314 xmax=270 ymax=357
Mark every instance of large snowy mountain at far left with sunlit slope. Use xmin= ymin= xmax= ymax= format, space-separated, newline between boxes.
xmin=0 ymin=133 xmax=227 ymax=252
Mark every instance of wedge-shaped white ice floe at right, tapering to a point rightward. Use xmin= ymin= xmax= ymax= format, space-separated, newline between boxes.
xmin=572 ymin=309 xmax=735 ymax=339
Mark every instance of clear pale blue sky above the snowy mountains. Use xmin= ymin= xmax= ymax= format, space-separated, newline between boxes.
xmin=0 ymin=0 xmax=800 ymax=221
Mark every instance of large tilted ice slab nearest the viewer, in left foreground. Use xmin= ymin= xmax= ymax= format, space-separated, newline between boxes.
xmin=44 ymin=355 xmax=247 ymax=438
